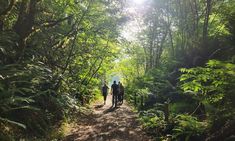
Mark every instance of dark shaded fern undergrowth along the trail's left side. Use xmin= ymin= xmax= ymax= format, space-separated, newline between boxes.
xmin=0 ymin=62 xmax=78 ymax=138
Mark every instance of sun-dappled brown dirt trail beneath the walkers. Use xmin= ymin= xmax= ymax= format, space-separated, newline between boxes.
xmin=64 ymin=95 xmax=151 ymax=141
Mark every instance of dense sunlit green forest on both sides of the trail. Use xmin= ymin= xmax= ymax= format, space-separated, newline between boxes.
xmin=0 ymin=0 xmax=235 ymax=141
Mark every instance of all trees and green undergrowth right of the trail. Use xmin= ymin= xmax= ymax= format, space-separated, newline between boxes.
xmin=119 ymin=0 xmax=235 ymax=140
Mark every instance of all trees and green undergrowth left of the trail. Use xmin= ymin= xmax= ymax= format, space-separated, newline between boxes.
xmin=0 ymin=0 xmax=125 ymax=140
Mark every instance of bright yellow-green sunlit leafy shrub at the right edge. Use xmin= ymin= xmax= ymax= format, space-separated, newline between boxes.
xmin=180 ymin=60 xmax=235 ymax=103
